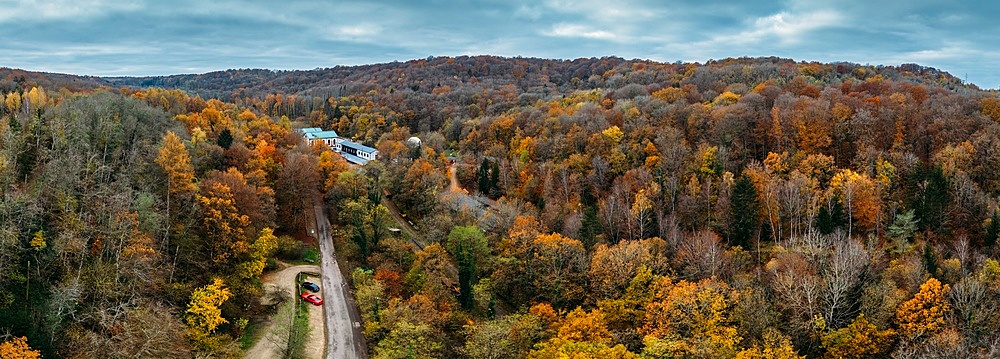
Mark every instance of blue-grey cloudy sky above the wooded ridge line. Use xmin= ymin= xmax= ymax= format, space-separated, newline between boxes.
xmin=0 ymin=0 xmax=1000 ymax=88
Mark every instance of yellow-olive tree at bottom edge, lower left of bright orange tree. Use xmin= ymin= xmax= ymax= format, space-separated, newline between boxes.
xmin=821 ymin=314 xmax=896 ymax=359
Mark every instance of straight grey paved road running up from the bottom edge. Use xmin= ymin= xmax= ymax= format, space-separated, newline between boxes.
xmin=313 ymin=205 xmax=368 ymax=359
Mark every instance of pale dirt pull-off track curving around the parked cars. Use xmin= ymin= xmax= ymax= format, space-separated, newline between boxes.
xmin=245 ymin=265 xmax=324 ymax=359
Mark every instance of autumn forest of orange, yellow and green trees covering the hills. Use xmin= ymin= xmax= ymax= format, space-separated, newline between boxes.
xmin=0 ymin=56 xmax=1000 ymax=358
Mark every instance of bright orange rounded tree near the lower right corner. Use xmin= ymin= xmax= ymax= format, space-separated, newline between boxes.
xmin=896 ymin=278 xmax=951 ymax=339
